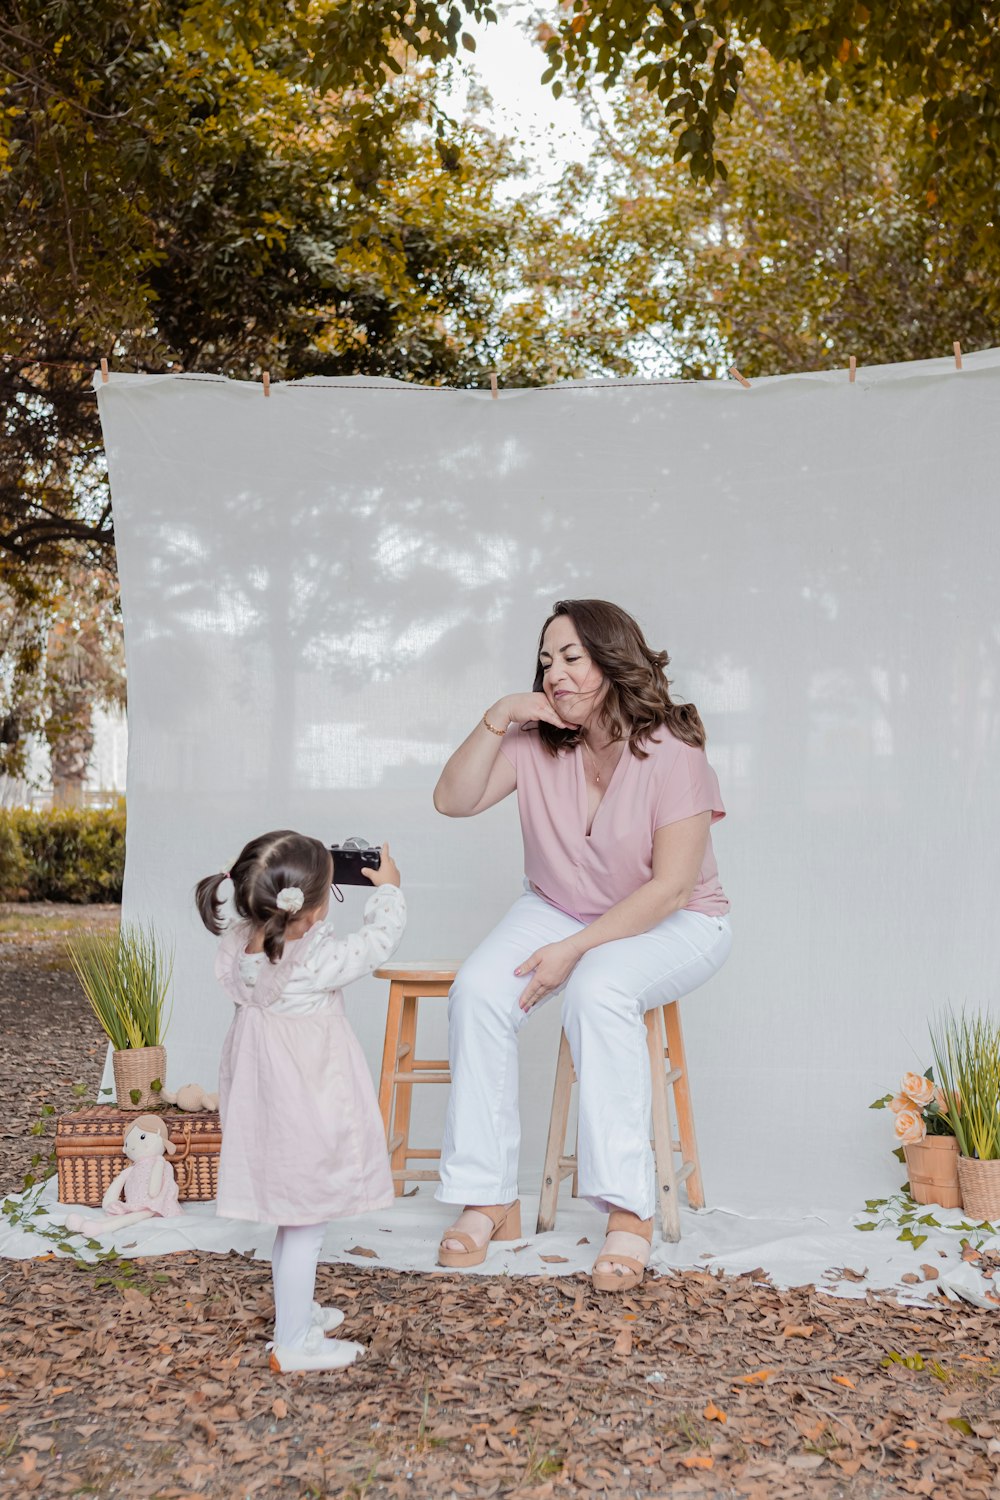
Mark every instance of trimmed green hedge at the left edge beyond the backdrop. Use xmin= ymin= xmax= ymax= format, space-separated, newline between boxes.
xmin=0 ymin=803 xmax=124 ymax=903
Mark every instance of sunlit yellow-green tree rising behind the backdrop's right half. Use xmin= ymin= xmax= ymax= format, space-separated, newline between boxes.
xmin=505 ymin=47 xmax=1000 ymax=378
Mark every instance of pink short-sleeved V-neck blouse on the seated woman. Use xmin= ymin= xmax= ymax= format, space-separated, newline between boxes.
xmin=501 ymin=725 xmax=729 ymax=923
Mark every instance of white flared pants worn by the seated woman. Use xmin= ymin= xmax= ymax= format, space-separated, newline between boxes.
xmin=436 ymin=891 xmax=732 ymax=1218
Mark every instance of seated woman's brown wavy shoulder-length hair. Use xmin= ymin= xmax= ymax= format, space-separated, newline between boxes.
xmin=535 ymin=599 xmax=705 ymax=761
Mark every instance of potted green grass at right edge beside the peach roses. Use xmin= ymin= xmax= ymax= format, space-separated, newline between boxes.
xmin=931 ymin=1014 xmax=1000 ymax=1223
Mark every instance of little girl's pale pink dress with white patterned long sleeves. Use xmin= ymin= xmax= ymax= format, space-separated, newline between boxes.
xmin=216 ymin=885 xmax=406 ymax=1224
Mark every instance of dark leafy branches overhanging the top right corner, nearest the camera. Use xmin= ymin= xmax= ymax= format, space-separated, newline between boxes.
xmin=527 ymin=0 xmax=1000 ymax=201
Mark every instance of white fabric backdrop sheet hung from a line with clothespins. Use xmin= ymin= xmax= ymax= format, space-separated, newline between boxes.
xmin=94 ymin=351 xmax=1000 ymax=1212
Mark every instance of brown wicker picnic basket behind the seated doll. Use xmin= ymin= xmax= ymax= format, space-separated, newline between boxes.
xmin=55 ymin=1104 xmax=222 ymax=1208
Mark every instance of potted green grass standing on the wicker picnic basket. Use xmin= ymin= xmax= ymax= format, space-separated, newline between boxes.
xmin=66 ymin=923 xmax=174 ymax=1110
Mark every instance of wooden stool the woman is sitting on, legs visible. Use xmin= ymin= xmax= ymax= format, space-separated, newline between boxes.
xmin=535 ymin=1001 xmax=705 ymax=1241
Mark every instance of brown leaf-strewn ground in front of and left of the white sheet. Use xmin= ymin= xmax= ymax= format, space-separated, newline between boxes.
xmin=0 ymin=914 xmax=1000 ymax=1500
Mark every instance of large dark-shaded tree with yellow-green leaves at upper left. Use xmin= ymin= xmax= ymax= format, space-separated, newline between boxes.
xmin=0 ymin=0 xmax=530 ymax=573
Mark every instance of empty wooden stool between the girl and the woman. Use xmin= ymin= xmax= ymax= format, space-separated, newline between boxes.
xmin=375 ymin=965 xmax=456 ymax=1199
